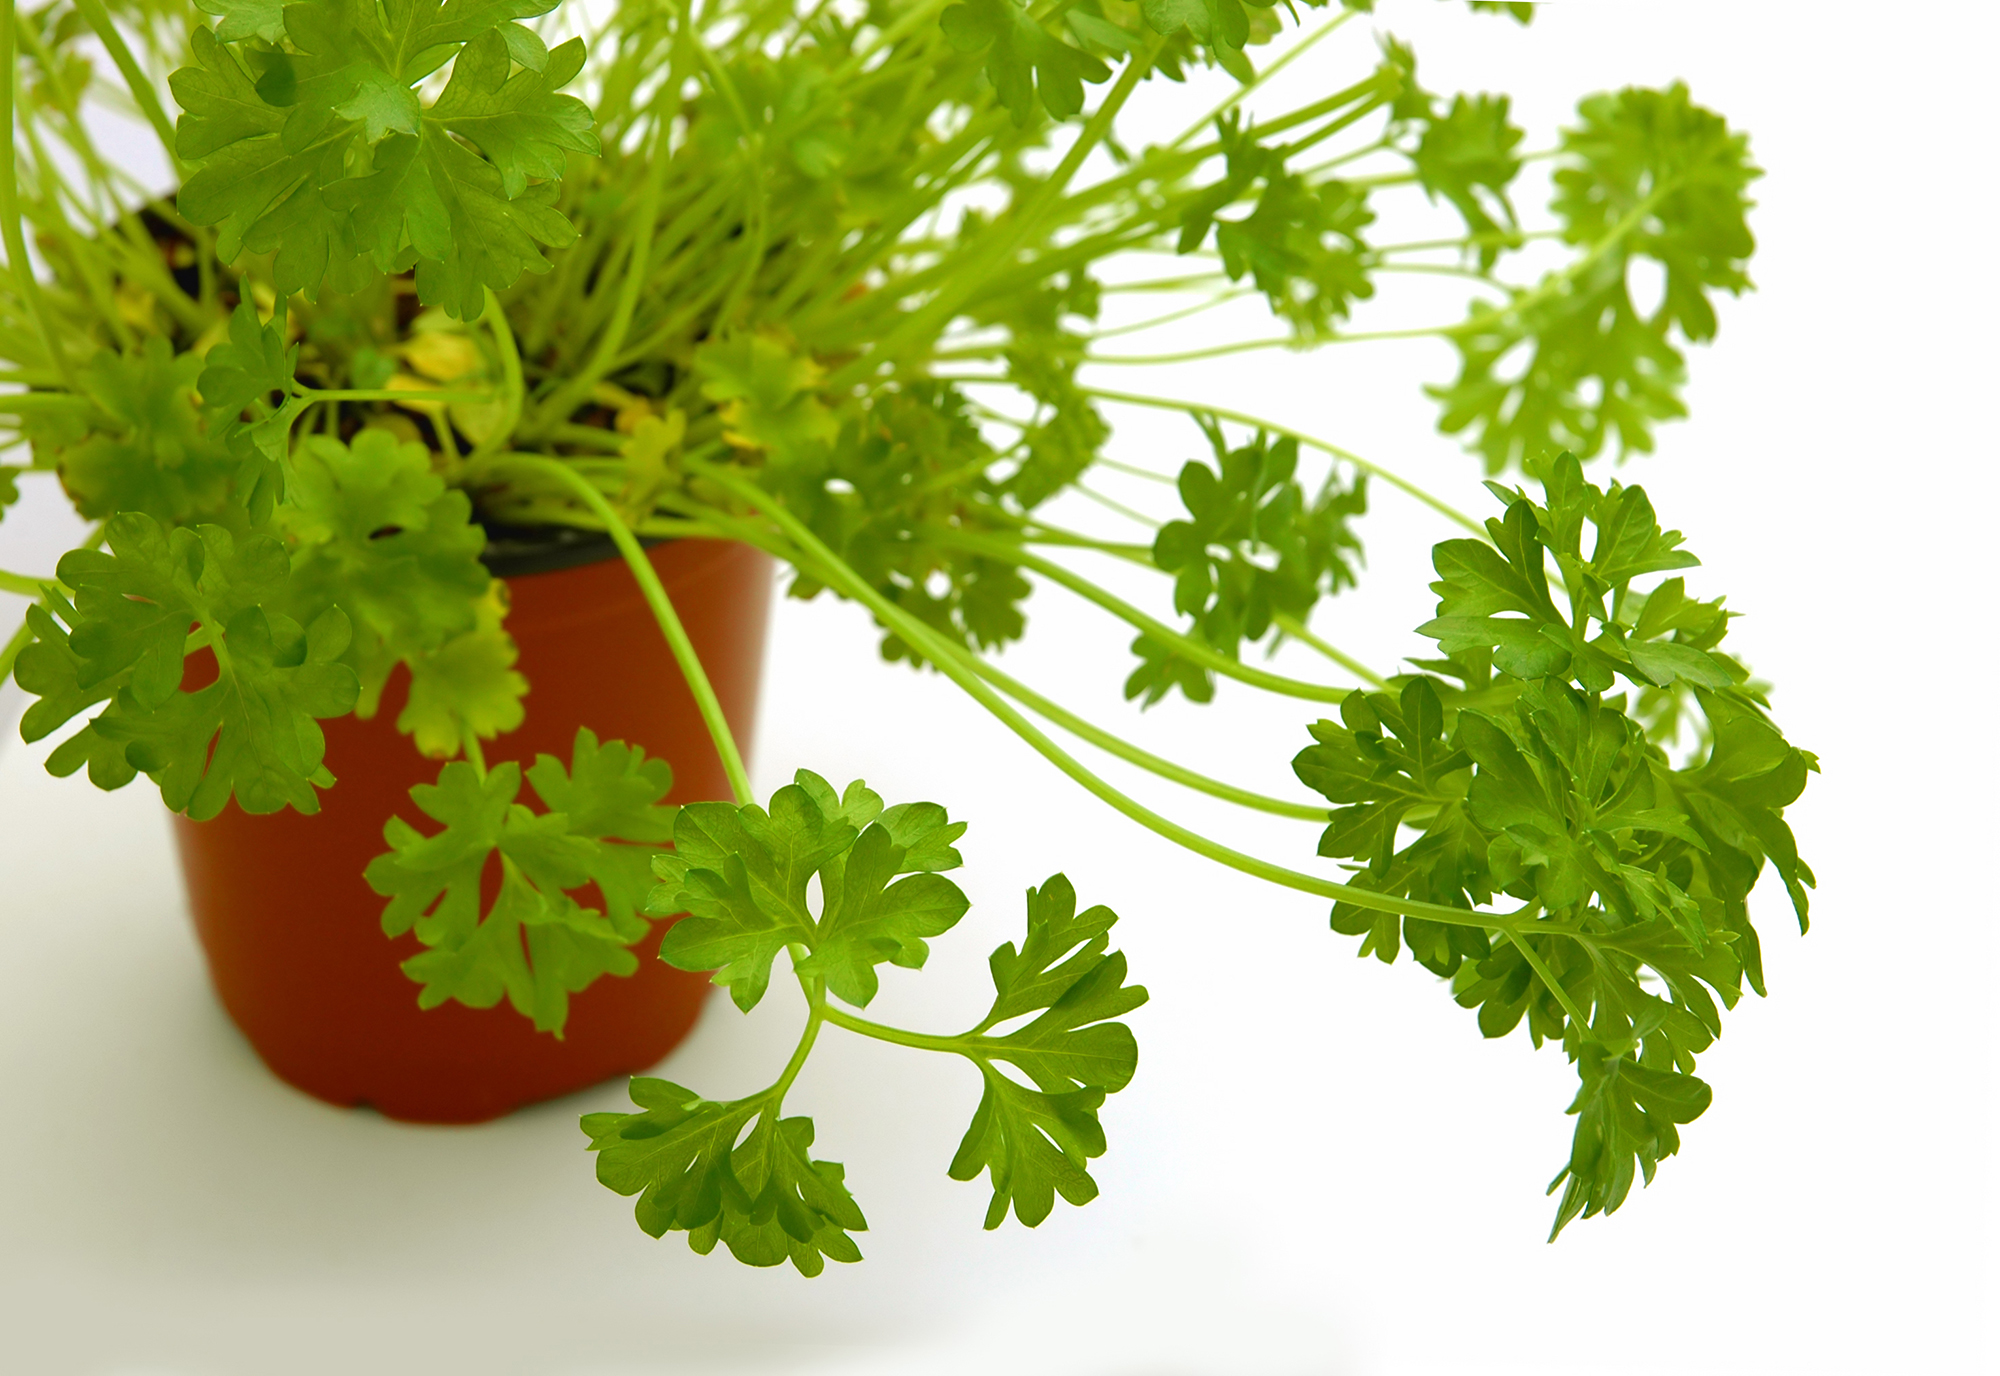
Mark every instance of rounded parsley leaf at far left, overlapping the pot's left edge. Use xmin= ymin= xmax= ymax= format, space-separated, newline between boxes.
xmin=16 ymin=512 xmax=356 ymax=820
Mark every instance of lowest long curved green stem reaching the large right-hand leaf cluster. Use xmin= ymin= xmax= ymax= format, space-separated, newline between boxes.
xmin=688 ymin=462 xmax=1528 ymax=936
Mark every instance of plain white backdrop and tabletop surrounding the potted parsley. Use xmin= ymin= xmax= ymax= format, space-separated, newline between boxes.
xmin=0 ymin=0 xmax=1996 ymax=1376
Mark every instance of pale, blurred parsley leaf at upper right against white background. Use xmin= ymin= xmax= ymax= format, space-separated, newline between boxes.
xmin=1426 ymin=84 xmax=1760 ymax=472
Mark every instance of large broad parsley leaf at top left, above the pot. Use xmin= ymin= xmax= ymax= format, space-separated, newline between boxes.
xmin=172 ymin=0 xmax=598 ymax=320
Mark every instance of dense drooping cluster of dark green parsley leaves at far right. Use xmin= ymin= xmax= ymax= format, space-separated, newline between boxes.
xmin=1294 ymin=456 xmax=1818 ymax=1232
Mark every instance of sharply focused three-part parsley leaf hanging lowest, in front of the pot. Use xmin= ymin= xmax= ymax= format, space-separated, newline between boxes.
xmin=582 ymin=770 xmax=1146 ymax=1276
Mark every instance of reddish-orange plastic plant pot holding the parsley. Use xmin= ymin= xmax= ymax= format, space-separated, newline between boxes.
xmin=174 ymin=540 xmax=770 ymax=1122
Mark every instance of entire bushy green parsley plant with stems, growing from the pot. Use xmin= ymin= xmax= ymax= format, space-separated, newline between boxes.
xmin=0 ymin=0 xmax=1816 ymax=1274
